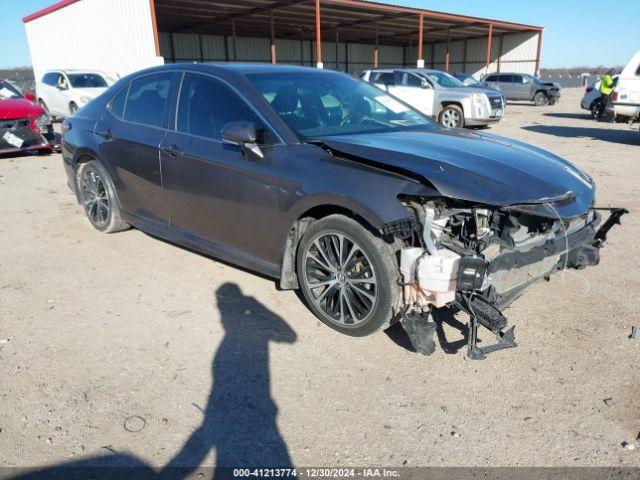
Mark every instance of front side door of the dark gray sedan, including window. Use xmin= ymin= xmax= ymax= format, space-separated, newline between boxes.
xmin=161 ymin=72 xmax=286 ymax=266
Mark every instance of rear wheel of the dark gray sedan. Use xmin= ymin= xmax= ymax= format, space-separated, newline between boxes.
xmin=78 ymin=160 xmax=129 ymax=233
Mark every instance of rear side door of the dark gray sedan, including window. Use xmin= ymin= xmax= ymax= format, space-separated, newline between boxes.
xmin=94 ymin=72 xmax=180 ymax=228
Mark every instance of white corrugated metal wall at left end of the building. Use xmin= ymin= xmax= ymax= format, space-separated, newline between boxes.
xmin=25 ymin=0 xmax=163 ymax=80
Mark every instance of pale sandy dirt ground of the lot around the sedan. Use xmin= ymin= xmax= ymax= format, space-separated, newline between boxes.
xmin=0 ymin=89 xmax=640 ymax=468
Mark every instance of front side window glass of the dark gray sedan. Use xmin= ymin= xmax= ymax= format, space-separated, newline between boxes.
xmin=176 ymin=74 xmax=276 ymax=145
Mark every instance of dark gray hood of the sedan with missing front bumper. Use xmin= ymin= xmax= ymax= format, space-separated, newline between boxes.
xmin=316 ymin=129 xmax=595 ymax=217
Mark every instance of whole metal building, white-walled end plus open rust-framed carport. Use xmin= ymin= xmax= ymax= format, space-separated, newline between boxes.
xmin=24 ymin=0 xmax=543 ymax=78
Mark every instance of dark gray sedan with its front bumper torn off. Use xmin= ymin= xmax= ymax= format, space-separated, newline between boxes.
xmin=63 ymin=64 xmax=627 ymax=358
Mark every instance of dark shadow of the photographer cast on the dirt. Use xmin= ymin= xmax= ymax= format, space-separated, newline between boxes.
xmin=11 ymin=283 xmax=297 ymax=480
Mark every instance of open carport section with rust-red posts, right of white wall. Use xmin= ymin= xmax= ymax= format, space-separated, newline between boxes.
xmin=151 ymin=0 xmax=543 ymax=73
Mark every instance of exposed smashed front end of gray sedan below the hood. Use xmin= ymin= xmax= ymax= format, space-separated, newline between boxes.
xmin=392 ymin=198 xmax=628 ymax=359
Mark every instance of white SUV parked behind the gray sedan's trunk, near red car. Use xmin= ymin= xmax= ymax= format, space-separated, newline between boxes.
xmin=36 ymin=70 xmax=115 ymax=117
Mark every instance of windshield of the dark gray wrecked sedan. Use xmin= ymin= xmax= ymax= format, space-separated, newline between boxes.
xmin=247 ymin=71 xmax=437 ymax=139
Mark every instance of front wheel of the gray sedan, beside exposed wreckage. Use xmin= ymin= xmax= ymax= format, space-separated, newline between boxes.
xmin=296 ymin=215 xmax=400 ymax=337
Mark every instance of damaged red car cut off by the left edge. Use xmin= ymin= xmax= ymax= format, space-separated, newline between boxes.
xmin=0 ymin=80 xmax=57 ymax=155
